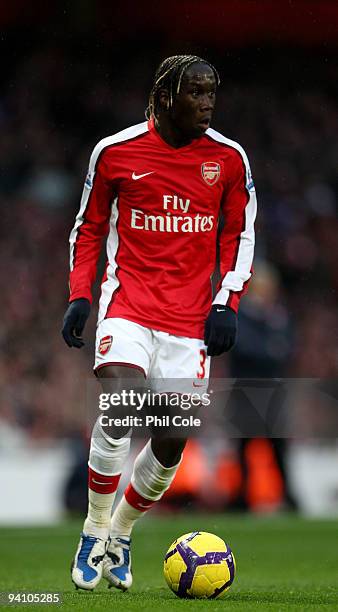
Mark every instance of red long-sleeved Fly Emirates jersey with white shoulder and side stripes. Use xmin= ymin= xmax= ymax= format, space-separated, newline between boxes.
xmin=70 ymin=120 xmax=256 ymax=338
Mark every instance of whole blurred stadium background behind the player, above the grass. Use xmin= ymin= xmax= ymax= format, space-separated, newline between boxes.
xmin=0 ymin=0 xmax=338 ymax=524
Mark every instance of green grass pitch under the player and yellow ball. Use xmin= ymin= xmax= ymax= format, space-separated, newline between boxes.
xmin=0 ymin=512 xmax=338 ymax=612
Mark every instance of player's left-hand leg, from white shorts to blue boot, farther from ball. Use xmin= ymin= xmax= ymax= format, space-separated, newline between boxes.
xmin=72 ymin=320 xmax=148 ymax=590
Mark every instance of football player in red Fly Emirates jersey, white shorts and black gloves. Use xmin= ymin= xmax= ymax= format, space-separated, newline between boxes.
xmin=62 ymin=55 xmax=256 ymax=590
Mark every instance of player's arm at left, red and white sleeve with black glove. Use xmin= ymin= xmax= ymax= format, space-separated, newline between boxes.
xmin=62 ymin=144 xmax=113 ymax=348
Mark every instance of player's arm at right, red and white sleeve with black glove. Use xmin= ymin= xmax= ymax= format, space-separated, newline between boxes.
xmin=205 ymin=151 xmax=257 ymax=355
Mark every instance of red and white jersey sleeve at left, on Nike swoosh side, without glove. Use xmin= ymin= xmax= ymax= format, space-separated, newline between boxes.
xmin=69 ymin=143 xmax=114 ymax=302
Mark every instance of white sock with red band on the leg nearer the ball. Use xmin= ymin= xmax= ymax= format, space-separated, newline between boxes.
xmin=110 ymin=440 xmax=181 ymax=536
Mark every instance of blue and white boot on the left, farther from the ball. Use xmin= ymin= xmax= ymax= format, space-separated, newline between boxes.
xmin=71 ymin=533 xmax=107 ymax=591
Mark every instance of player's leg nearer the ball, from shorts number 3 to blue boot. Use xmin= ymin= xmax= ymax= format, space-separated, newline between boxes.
xmin=104 ymin=332 xmax=210 ymax=589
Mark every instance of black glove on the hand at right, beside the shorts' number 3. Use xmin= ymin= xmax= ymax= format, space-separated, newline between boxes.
xmin=204 ymin=304 xmax=237 ymax=357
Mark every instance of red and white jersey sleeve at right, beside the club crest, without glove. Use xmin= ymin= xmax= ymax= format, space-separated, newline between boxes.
xmin=213 ymin=149 xmax=257 ymax=312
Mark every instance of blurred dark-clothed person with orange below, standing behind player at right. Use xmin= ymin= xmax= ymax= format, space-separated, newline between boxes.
xmin=223 ymin=260 xmax=296 ymax=510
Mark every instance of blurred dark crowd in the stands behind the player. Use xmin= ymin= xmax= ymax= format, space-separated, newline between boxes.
xmin=0 ymin=44 xmax=338 ymax=443
